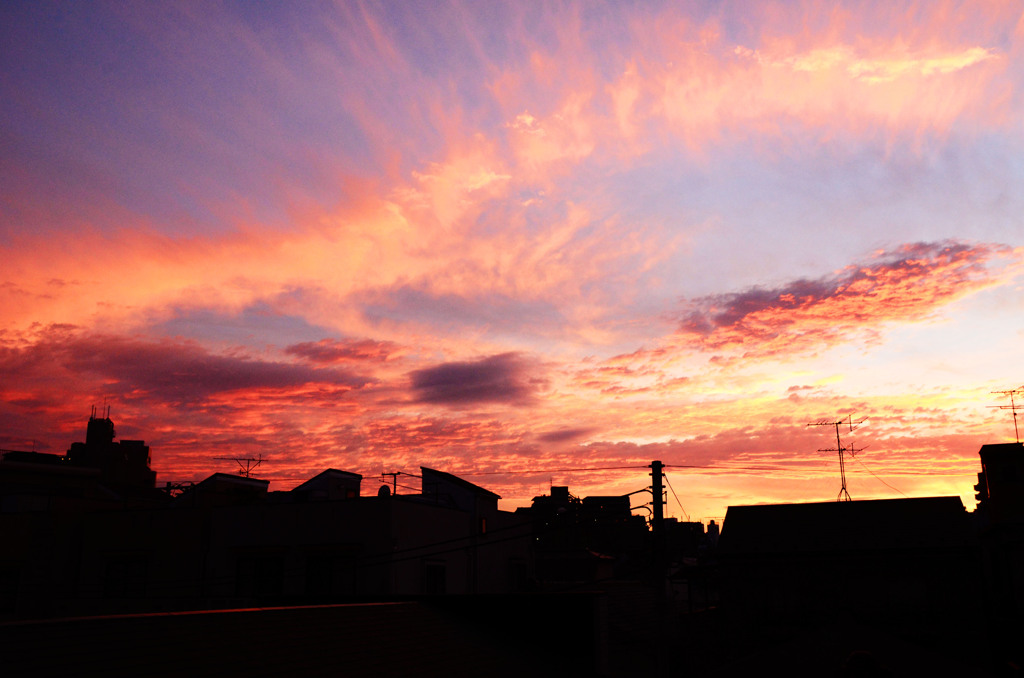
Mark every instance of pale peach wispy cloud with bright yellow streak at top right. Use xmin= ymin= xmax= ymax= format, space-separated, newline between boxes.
xmin=607 ymin=3 xmax=1020 ymax=154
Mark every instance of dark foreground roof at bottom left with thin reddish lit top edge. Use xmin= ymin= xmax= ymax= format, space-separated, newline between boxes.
xmin=0 ymin=594 xmax=604 ymax=678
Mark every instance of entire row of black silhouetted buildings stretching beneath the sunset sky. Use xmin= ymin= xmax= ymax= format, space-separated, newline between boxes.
xmin=0 ymin=412 xmax=1024 ymax=675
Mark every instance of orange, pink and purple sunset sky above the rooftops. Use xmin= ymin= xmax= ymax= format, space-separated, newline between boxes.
xmin=0 ymin=0 xmax=1024 ymax=519
